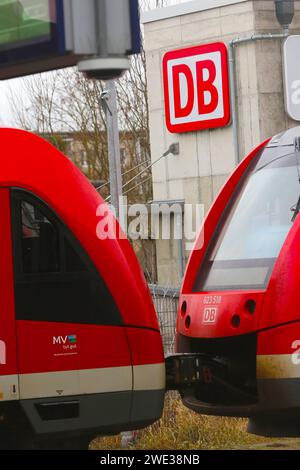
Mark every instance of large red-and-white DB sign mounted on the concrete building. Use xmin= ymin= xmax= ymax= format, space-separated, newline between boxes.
xmin=163 ymin=43 xmax=230 ymax=132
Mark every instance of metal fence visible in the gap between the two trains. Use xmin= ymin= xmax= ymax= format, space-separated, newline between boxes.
xmin=149 ymin=284 xmax=180 ymax=354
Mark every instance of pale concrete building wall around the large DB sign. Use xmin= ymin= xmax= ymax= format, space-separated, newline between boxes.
xmin=144 ymin=0 xmax=300 ymax=286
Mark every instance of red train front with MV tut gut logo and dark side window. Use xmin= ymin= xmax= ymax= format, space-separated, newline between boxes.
xmin=0 ymin=129 xmax=165 ymax=447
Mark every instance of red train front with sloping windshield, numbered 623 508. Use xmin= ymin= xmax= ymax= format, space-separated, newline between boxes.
xmin=177 ymin=127 xmax=300 ymax=436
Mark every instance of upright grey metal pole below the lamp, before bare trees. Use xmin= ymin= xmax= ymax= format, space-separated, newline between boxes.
xmin=106 ymin=80 xmax=122 ymax=218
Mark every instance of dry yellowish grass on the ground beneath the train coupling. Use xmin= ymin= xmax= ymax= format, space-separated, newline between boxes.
xmin=91 ymin=396 xmax=270 ymax=450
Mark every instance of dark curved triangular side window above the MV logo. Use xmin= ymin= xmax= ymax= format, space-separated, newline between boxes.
xmin=11 ymin=189 xmax=122 ymax=325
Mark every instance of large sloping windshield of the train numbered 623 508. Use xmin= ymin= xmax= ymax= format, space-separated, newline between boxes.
xmin=194 ymin=148 xmax=300 ymax=292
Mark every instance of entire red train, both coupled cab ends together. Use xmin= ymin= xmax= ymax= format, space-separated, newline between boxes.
xmin=0 ymin=128 xmax=300 ymax=448
